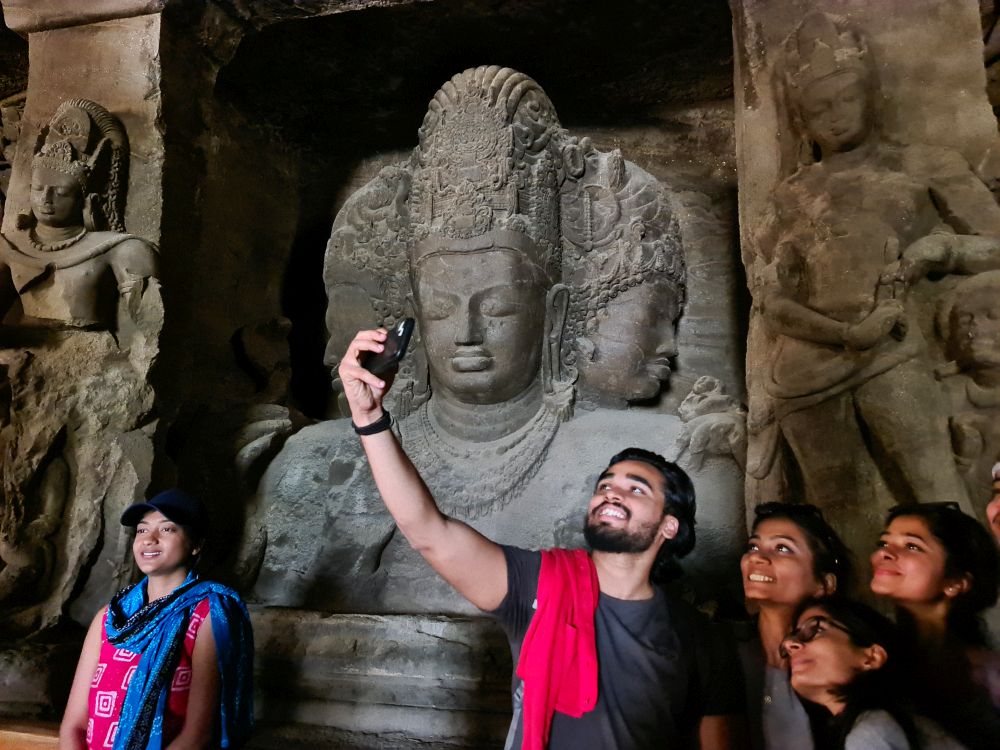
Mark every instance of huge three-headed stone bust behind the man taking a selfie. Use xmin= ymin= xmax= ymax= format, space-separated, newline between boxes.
xmin=249 ymin=67 xmax=744 ymax=613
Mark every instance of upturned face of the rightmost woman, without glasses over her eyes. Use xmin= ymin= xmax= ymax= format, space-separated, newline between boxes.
xmin=871 ymin=516 xmax=953 ymax=604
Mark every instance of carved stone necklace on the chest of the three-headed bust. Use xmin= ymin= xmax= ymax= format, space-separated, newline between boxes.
xmin=399 ymin=402 xmax=561 ymax=519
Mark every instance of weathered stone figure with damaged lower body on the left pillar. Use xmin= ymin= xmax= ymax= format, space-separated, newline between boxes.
xmin=0 ymin=99 xmax=163 ymax=635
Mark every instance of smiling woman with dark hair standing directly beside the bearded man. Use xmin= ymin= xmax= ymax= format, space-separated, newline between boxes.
xmin=739 ymin=503 xmax=851 ymax=750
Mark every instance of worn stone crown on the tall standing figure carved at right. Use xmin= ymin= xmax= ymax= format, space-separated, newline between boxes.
xmin=785 ymin=12 xmax=870 ymax=90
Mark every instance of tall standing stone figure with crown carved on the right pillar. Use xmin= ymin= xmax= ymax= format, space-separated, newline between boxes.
xmin=748 ymin=13 xmax=1000 ymax=533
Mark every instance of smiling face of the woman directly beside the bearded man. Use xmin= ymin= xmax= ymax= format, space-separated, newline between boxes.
xmin=740 ymin=518 xmax=829 ymax=607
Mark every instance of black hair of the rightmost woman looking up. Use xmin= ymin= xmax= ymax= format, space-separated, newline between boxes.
xmin=885 ymin=503 xmax=1000 ymax=646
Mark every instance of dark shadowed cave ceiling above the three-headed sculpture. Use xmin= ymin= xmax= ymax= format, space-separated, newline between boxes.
xmin=217 ymin=0 xmax=732 ymax=151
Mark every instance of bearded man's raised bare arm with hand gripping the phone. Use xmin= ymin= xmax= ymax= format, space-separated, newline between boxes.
xmin=337 ymin=329 xmax=507 ymax=611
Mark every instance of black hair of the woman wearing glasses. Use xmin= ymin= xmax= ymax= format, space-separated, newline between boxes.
xmin=792 ymin=596 xmax=922 ymax=750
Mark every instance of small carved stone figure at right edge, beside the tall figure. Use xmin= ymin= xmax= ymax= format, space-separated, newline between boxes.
xmin=938 ymin=271 xmax=1000 ymax=510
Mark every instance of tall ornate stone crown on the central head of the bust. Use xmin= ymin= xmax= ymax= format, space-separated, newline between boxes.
xmin=408 ymin=66 xmax=561 ymax=280
